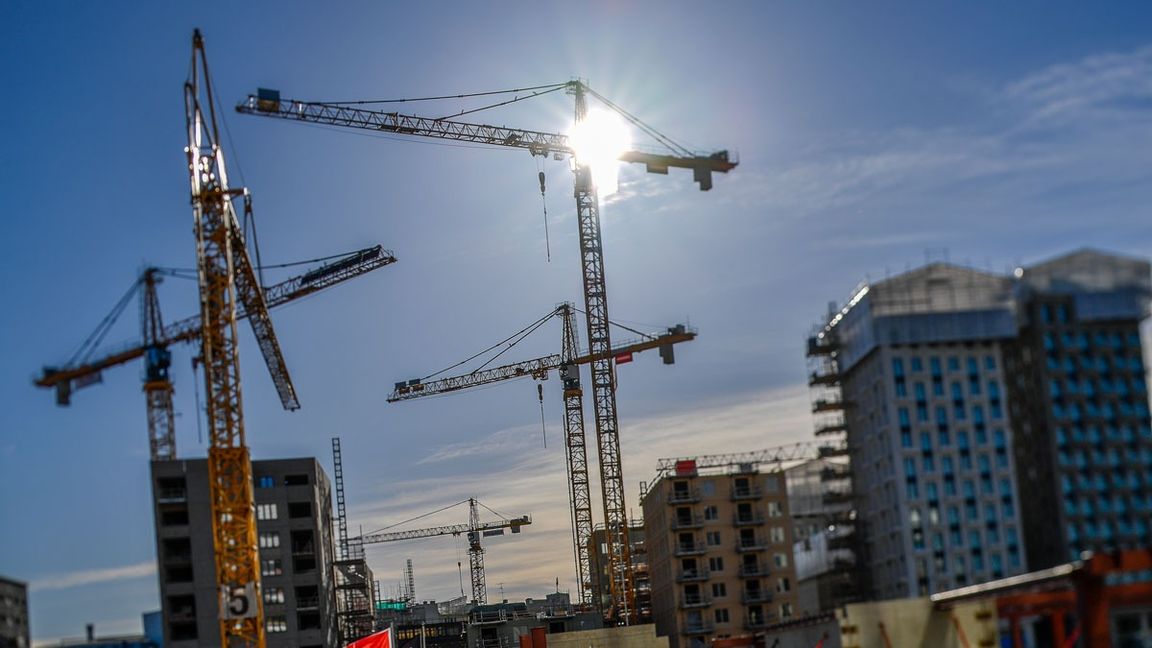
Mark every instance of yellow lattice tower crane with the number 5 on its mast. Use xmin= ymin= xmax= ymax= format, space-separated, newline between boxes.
xmin=184 ymin=29 xmax=300 ymax=648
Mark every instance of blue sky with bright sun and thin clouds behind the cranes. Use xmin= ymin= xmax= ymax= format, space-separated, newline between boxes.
xmin=0 ymin=1 xmax=1152 ymax=640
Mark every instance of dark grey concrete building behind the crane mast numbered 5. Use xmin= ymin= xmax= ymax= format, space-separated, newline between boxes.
xmin=152 ymin=458 xmax=338 ymax=648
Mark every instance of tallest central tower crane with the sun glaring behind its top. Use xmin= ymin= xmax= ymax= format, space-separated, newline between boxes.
xmin=236 ymin=76 xmax=737 ymax=624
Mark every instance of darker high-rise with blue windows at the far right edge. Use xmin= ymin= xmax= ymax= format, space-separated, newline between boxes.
xmin=1006 ymin=250 xmax=1152 ymax=568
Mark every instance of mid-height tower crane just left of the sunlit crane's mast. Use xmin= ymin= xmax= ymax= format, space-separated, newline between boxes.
xmin=388 ymin=303 xmax=696 ymax=606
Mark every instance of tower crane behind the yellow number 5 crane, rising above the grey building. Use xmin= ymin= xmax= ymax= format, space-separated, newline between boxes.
xmin=35 ymin=246 xmax=396 ymax=460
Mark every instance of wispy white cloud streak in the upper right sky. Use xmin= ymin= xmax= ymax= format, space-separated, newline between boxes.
xmin=700 ymin=46 xmax=1152 ymax=230
